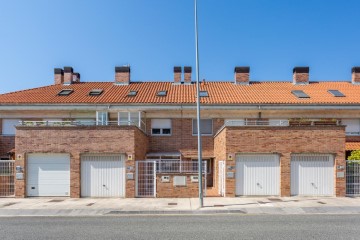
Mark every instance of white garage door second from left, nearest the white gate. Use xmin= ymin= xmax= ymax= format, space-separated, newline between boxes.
xmin=81 ymin=155 xmax=125 ymax=197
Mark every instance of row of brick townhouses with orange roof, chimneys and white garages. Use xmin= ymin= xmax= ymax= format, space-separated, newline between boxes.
xmin=0 ymin=66 xmax=360 ymax=198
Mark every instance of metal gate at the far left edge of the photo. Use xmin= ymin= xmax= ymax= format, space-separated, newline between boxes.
xmin=0 ymin=160 xmax=15 ymax=197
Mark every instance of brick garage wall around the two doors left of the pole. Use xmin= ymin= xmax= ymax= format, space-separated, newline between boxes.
xmin=15 ymin=126 xmax=148 ymax=198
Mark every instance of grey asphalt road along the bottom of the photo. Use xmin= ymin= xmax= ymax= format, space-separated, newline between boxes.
xmin=0 ymin=215 xmax=360 ymax=240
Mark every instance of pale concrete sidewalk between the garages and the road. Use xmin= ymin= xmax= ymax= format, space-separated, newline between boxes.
xmin=0 ymin=197 xmax=360 ymax=217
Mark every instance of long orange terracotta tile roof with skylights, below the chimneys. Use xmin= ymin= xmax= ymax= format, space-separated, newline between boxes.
xmin=0 ymin=82 xmax=360 ymax=104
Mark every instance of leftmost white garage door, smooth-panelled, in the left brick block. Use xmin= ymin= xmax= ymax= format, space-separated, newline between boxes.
xmin=27 ymin=153 xmax=70 ymax=197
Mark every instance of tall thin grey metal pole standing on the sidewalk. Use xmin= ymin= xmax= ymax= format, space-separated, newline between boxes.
xmin=195 ymin=0 xmax=206 ymax=208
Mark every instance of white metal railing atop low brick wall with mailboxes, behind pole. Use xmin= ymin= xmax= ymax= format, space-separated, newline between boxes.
xmin=156 ymin=160 xmax=206 ymax=173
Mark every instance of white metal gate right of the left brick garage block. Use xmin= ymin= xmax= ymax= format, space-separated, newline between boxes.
xmin=135 ymin=161 xmax=156 ymax=197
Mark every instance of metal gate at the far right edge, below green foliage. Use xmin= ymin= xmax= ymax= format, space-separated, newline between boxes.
xmin=346 ymin=160 xmax=360 ymax=196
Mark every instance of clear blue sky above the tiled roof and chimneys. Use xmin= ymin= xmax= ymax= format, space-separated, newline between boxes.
xmin=0 ymin=0 xmax=360 ymax=93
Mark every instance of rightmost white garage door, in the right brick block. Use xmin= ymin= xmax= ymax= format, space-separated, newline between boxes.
xmin=291 ymin=154 xmax=335 ymax=196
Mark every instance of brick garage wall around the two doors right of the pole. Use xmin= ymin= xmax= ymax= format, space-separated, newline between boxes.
xmin=215 ymin=126 xmax=346 ymax=197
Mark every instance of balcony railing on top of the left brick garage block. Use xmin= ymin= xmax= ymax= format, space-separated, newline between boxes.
xmin=19 ymin=120 xmax=146 ymax=132
